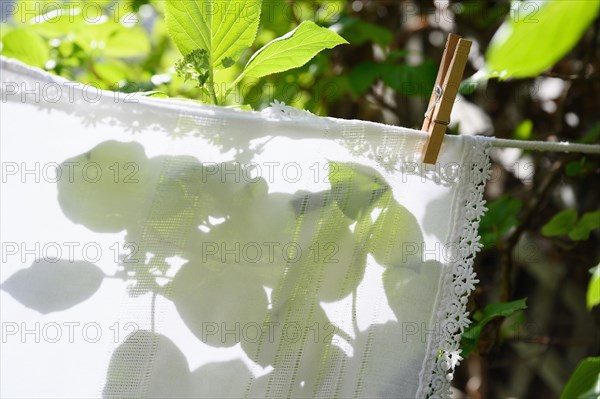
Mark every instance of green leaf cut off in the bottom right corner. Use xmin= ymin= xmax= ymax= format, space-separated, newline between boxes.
xmin=560 ymin=357 xmax=600 ymax=399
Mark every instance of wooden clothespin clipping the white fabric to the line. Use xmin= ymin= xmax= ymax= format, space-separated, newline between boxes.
xmin=421 ymin=33 xmax=471 ymax=164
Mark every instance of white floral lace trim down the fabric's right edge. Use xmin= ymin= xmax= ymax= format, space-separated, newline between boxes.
xmin=417 ymin=137 xmax=491 ymax=399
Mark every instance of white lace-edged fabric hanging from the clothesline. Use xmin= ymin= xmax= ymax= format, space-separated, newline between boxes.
xmin=0 ymin=59 xmax=489 ymax=398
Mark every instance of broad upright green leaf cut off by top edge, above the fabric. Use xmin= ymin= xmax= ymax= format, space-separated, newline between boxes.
xmin=165 ymin=0 xmax=261 ymax=70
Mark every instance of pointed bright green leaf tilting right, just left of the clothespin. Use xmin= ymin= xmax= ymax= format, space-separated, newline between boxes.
xmin=238 ymin=21 xmax=348 ymax=80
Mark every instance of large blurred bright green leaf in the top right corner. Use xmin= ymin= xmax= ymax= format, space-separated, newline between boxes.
xmin=486 ymin=0 xmax=600 ymax=78
